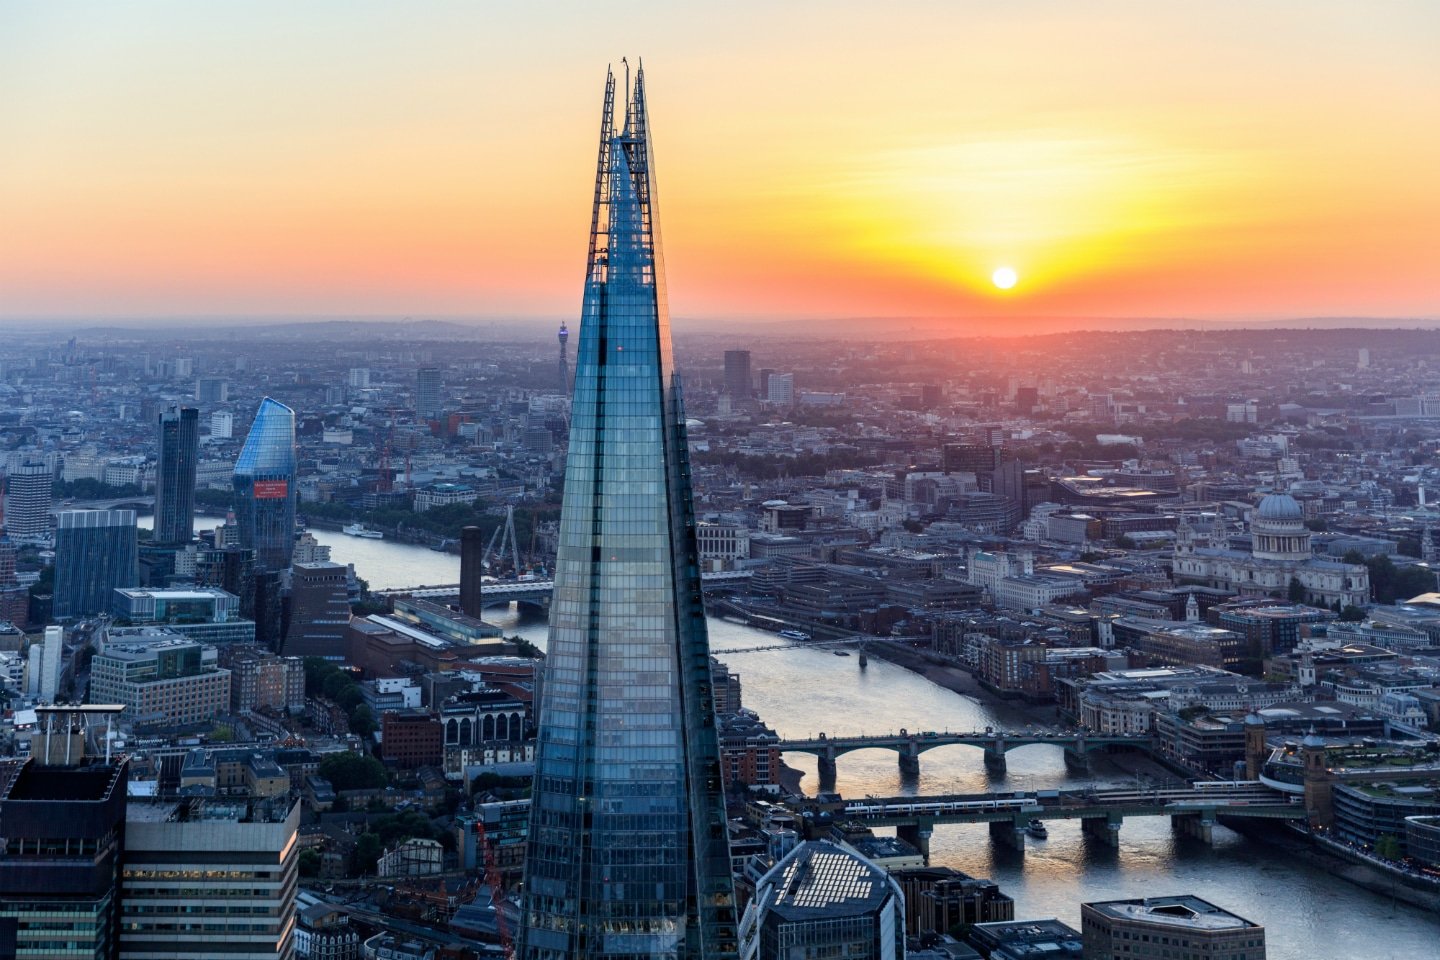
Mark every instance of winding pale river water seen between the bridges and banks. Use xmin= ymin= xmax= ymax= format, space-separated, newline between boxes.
xmin=185 ymin=521 xmax=1440 ymax=960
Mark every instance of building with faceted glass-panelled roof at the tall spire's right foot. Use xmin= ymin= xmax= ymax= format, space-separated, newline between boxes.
xmin=740 ymin=841 xmax=904 ymax=960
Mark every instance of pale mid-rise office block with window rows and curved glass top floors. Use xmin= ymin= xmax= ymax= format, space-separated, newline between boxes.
xmin=89 ymin=626 xmax=230 ymax=727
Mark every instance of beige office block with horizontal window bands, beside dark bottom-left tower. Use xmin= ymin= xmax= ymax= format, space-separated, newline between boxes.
xmin=120 ymin=797 xmax=300 ymax=960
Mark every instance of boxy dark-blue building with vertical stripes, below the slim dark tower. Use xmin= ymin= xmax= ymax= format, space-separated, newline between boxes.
xmin=53 ymin=510 xmax=140 ymax=620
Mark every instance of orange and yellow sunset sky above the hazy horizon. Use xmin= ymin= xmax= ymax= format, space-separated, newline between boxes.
xmin=0 ymin=0 xmax=1440 ymax=326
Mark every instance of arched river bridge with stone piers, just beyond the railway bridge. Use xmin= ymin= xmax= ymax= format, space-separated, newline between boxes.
xmin=779 ymin=730 xmax=1153 ymax=783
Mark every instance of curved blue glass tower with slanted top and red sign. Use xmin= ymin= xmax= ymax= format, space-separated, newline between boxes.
xmin=232 ymin=397 xmax=295 ymax=570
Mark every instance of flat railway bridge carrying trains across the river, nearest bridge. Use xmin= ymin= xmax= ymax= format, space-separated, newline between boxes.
xmin=819 ymin=780 xmax=1306 ymax=859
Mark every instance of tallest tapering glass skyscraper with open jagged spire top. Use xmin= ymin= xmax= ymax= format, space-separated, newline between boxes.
xmin=520 ymin=71 xmax=737 ymax=960
